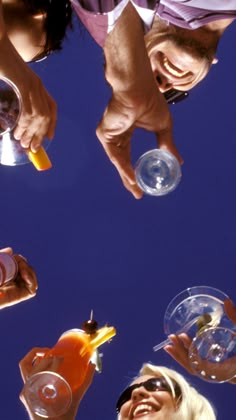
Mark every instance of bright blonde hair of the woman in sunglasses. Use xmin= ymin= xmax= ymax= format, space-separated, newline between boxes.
xmin=118 ymin=363 xmax=216 ymax=420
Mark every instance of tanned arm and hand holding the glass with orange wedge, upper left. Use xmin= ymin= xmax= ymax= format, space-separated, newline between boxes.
xmin=0 ymin=0 xmax=57 ymax=152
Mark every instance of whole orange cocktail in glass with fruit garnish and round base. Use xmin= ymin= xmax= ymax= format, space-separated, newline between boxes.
xmin=25 ymin=327 xmax=115 ymax=418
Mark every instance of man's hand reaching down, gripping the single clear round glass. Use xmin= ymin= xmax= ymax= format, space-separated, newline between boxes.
xmin=96 ymin=86 xmax=182 ymax=199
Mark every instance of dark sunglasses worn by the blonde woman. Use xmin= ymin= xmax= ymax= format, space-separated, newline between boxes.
xmin=116 ymin=376 xmax=182 ymax=413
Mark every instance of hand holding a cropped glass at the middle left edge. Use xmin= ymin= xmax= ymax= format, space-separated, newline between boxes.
xmin=0 ymin=248 xmax=38 ymax=309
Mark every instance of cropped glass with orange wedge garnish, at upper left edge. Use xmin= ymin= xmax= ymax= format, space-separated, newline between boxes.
xmin=0 ymin=78 xmax=52 ymax=170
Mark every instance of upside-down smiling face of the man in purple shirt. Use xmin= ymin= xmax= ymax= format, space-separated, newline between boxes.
xmin=145 ymin=19 xmax=217 ymax=92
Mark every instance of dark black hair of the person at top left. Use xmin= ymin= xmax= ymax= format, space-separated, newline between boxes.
xmin=23 ymin=0 xmax=72 ymax=61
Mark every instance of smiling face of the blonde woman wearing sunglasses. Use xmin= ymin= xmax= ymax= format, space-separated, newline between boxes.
xmin=120 ymin=375 xmax=176 ymax=420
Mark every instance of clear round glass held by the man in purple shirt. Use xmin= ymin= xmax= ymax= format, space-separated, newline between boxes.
xmin=135 ymin=149 xmax=181 ymax=196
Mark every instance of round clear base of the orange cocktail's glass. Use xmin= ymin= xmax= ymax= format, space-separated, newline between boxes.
xmin=25 ymin=371 xmax=72 ymax=418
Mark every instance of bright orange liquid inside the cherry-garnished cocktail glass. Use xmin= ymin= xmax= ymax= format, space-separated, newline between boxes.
xmin=44 ymin=329 xmax=94 ymax=392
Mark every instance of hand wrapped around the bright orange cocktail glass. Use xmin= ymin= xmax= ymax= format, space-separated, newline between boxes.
xmin=19 ymin=348 xmax=95 ymax=420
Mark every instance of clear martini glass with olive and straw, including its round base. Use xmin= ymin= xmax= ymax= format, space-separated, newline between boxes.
xmin=154 ymin=286 xmax=236 ymax=382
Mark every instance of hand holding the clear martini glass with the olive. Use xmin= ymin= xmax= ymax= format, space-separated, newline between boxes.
xmin=164 ymin=299 xmax=236 ymax=384
